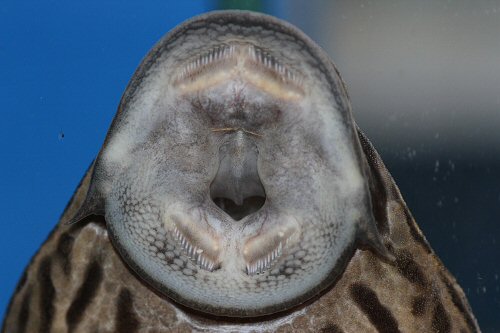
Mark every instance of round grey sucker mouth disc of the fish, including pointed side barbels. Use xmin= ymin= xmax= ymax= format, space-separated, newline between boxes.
xmin=69 ymin=13 xmax=386 ymax=316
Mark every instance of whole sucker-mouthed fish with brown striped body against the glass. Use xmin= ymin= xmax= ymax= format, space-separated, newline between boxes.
xmin=2 ymin=11 xmax=479 ymax=333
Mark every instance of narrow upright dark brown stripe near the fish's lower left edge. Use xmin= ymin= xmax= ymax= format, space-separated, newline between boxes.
xmin=37 ymin=257 xmax=56 ymax=332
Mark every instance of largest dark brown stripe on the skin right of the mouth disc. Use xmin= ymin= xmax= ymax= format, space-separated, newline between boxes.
xmin=351 ymin=283 xmax=400 ymax=333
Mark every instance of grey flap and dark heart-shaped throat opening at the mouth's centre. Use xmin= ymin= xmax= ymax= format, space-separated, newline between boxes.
xmin=210 ymin=130 xmax=265 ymax=219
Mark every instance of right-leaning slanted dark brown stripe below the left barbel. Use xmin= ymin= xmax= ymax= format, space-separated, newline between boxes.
xmin=66 ymin=261 xmax=102 ymax=332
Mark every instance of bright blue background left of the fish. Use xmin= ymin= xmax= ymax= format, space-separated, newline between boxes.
xmin=0 ymin=1 xmax=219 ymax=317
